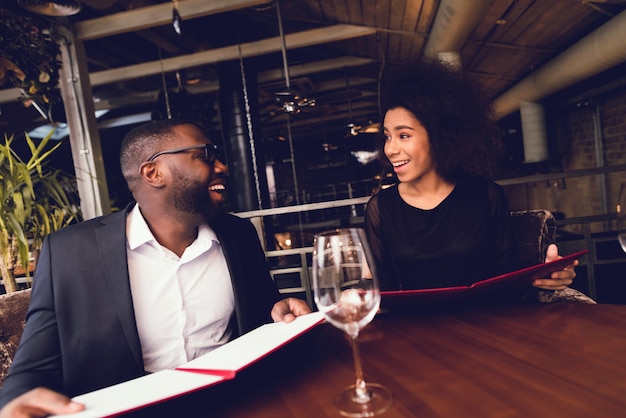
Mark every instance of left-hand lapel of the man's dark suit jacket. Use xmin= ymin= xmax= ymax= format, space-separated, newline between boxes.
xmin=94 ymin=205 xmax=143 ymax=370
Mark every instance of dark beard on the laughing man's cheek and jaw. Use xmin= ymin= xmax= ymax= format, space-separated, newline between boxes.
xmin=171 ymin=169 xmax=218 ymax=224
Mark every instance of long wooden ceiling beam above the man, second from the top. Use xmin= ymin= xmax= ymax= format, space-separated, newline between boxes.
xmin=90 ymin=24 xmax=376 ymax=86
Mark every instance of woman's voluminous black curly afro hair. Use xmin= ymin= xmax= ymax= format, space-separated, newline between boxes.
xmin=381 ymin=61 xmax=501 ymax=182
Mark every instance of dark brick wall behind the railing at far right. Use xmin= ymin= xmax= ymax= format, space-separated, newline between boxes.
xmin=507 ymin=87 xmax=626 ymax=233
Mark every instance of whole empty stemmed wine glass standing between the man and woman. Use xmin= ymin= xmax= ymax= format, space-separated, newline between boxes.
xmin=313 ymin=228 xmax=392 ymax=417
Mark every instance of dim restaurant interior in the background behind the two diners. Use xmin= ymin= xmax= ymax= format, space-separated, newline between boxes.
xmin=0 ymin=0 xmax=626 ymax=304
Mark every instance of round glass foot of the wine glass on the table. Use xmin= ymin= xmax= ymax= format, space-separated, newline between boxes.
xmin=335 ymin=383 xmax=393 ymax=417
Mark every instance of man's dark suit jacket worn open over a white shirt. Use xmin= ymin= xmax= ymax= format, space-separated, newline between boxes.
xmin=0 ymin=205 xmax=279 ymax=407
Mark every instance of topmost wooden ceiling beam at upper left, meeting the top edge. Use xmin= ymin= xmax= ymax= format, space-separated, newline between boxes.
xmin=74 ymin=0 xmax=269 ymax=41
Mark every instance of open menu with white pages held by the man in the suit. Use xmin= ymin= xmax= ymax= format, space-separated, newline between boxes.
xmin=53 ymin=312 xmax=324 ymax=418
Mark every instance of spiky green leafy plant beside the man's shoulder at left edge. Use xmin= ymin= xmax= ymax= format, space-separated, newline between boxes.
xmin=0 ymin=131 xmax=80 ymax=293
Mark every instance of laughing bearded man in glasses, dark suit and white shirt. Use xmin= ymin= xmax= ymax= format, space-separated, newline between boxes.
xmin=0 ymin=120 xmax=310 ymax=417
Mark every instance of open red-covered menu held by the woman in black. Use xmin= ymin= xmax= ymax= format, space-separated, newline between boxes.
xmin=380 ymin=250 xmax=589 ymax=309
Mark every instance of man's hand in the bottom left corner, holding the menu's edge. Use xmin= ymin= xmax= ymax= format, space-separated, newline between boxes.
xmin=0 ymin=388 xmax=85 ymax=418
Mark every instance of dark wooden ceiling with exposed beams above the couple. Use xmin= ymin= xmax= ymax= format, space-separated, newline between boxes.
xmin=0 ymin=0 xmax=626 ymax=142
